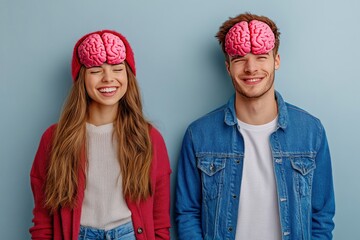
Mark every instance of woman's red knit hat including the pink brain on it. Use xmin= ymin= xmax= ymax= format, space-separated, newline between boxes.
xmin=72 ymin=30 xmax=136 ymax=81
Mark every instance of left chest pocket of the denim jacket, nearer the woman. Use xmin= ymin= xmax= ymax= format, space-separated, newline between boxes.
xmin=197 ymin=156 xmax=226 ymax=199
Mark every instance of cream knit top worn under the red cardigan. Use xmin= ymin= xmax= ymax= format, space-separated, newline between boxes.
xmin=80 ymin=123 xmax=131 ymax=230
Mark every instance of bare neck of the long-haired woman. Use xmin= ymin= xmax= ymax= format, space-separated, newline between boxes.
xmin=87 ymin=104 xmax=118 ymax=126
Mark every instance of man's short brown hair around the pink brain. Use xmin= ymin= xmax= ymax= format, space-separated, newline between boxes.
xmin=215 ymin=12 xmax=280 ymax=61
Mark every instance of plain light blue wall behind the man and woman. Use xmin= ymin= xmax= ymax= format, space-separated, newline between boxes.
xmin=0 ymin=0 xmax=360 ymax=239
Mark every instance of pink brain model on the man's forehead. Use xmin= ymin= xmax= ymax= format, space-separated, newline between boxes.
xmin=225 ymin=20 xmax=275 ymax=56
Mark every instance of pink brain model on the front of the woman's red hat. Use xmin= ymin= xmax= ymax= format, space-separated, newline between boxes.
xmin=78 ymin=32 xmax=126 ymax=68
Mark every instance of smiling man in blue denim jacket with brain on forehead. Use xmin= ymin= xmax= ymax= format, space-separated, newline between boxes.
xmin=176 ymin=13 xmax=335 ymax=240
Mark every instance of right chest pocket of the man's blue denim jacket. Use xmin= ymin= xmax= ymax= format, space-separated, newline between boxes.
xmin=290 ymin=156 xmax=316 ymax=197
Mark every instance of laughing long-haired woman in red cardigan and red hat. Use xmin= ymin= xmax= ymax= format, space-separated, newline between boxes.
xmin=30 ymin=30 xmax=171 ymax=240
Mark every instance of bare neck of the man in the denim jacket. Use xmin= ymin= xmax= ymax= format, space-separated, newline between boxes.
xmin=235 ymin=89 xmax=278 ymax=125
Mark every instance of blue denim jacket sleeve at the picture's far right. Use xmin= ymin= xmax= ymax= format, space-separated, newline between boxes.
xmin=311 ymin=124 xmax=335 ymax=240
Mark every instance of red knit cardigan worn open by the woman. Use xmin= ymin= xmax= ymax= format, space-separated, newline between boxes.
xmin=30 ymin=125 xmax=171 ymax=240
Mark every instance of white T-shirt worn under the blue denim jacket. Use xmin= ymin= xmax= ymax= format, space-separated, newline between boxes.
xmin=235 ymin=118 xmax=281 ymax=240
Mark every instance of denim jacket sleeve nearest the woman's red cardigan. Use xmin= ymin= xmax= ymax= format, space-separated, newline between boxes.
xmin=175 ymin=128 xmax=203 ymax=240
